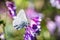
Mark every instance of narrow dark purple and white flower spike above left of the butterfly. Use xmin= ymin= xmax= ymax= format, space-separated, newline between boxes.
xmin=6 ymin=1 xmax=16 ymax=17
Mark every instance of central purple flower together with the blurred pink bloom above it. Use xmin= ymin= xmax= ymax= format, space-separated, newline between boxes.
xmin=24 ymin=8 xmax=43 ymax=40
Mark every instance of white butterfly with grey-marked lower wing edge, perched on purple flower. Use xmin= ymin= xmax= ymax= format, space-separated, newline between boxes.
xmin=13 ymin=9 xmax=28 ymax=30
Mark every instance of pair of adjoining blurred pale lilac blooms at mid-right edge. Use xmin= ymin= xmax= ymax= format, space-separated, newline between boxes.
xmin=47 ymin=15 xmax=60 ymax=36
